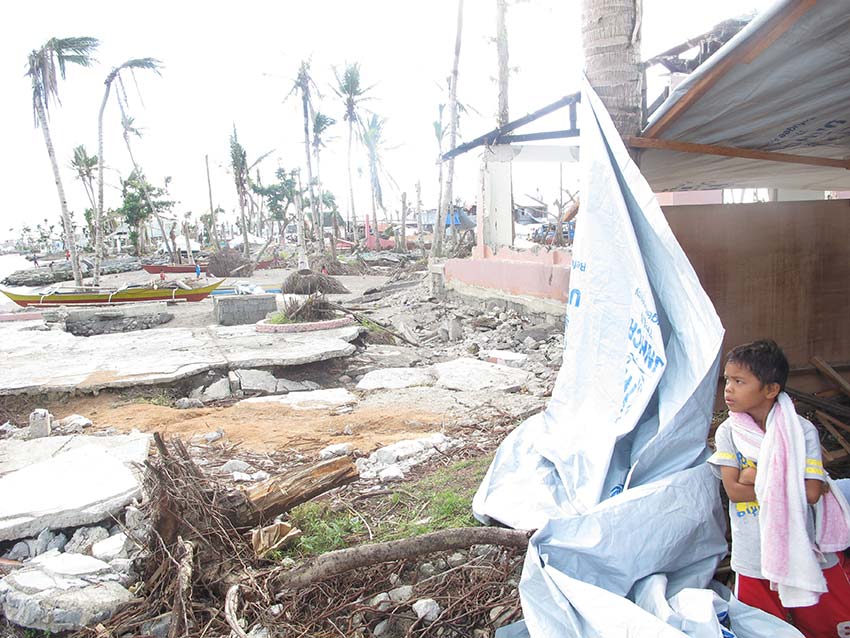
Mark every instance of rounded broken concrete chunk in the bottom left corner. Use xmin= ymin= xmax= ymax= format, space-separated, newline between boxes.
xmin=0 ymin=550 xmax=133 ymax=633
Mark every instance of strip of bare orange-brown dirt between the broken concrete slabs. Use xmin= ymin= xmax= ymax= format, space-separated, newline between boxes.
xmin=50 ymin=393 xmax=444 ymax=455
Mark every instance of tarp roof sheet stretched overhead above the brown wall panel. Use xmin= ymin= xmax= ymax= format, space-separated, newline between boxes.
xmin=641 ymin=0 xmax=850 ymax=191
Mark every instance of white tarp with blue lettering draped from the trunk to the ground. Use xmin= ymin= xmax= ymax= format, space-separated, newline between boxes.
xmin=473 ymin=77 xmax=800 ymax=638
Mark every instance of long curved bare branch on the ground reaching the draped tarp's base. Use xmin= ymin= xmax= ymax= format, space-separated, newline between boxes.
xmin=270 ymin=527 xmax=532 ymax=589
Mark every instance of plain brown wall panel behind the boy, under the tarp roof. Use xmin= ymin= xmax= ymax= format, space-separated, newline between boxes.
xmin=664 ymin=200 xmax=850 ymax=366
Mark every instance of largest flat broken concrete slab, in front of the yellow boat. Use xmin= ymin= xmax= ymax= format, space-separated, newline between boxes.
xmin=0 ymin=322 xmax=362 ymax=396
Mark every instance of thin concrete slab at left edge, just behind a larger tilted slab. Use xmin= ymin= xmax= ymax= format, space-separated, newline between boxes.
xmin=0 ymin=432 xmax=151 ymax=476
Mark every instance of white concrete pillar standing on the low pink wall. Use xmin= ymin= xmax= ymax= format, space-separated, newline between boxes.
xmin=478 ymin=145 xmax=514 ymax=249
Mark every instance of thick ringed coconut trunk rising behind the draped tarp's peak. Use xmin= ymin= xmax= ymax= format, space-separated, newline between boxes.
xmin=581 ymin=0 xmax=643 ymax=145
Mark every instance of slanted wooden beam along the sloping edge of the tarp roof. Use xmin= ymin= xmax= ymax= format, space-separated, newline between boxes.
xmin=644 ymin=0 xmax=817 ymax=137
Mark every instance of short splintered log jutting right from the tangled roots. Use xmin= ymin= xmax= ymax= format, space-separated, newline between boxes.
xmin=226 ymin=456 xmax=360 ymax=527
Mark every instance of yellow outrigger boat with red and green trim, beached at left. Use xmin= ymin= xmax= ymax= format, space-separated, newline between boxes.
xmin=0 ymin=279 xmax=224 ymax=307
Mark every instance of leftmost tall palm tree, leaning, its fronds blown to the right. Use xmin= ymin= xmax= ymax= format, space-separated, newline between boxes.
xmin=27 ymin=37 xmax=100 ymax=286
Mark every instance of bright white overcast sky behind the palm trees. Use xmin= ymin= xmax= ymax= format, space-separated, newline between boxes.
xmin=0 ymin=0 xmax=770 ymax=244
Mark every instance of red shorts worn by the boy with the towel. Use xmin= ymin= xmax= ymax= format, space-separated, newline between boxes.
xmin=735 ymin=563 xmax=850 ymax=638
